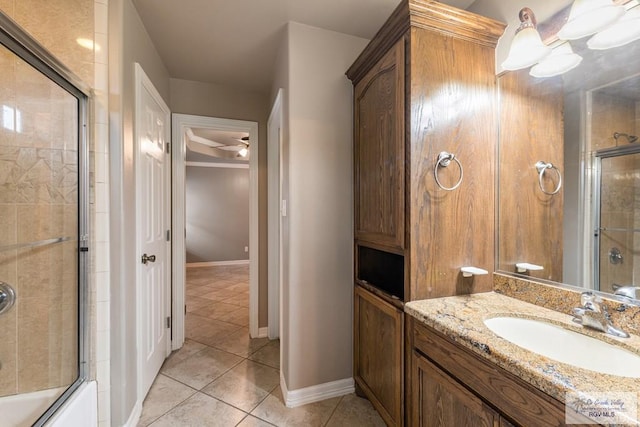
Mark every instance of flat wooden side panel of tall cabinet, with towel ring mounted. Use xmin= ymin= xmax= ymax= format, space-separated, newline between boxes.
xmin=407 ymin=29 xmax=498 ymax=300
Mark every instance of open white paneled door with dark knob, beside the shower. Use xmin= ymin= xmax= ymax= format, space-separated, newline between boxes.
xmin=135 ymin=64 xmax=171 ymax=400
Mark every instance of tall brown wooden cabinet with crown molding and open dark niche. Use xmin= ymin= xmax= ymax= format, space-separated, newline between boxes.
xmin=347 ymin=0 xmax=504 ymax=425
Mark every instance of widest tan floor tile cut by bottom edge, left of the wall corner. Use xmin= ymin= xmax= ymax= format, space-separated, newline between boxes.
xmin=153 ymin=393 xmax=246 ymax=427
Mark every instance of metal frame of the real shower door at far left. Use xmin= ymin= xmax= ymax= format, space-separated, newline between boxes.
xmin=0 ymin=11 xmax=91 ymax=427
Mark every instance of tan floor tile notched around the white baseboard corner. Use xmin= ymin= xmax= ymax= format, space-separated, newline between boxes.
xmin=251 ymin=387 xmax=341 ymax=427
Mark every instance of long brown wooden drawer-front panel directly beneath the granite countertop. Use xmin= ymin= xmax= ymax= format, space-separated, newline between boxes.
xmin=409 ymin=318 xmax=580 ymax=426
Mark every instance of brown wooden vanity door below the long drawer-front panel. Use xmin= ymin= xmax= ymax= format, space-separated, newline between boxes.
xmin=411 ymin=351 xmax=506 ymax=427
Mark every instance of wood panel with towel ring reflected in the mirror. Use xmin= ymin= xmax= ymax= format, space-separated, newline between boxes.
xmin=498 ymin=70 xmax=564 ymax=282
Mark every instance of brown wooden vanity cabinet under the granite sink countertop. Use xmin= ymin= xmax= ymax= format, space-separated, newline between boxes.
xmin=407 ymin=316 xmax=576 ymax=427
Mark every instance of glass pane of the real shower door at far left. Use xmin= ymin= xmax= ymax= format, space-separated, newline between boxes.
xmin=0 ymin=18 xmax=86 ymax=426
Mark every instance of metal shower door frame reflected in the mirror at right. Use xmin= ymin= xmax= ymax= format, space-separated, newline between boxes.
xmin=592 ymin=144 xmax=640 ymax=291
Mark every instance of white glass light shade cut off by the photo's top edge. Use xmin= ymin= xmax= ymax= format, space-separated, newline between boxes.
xmin=558 ymin=0 xmax=625 ymax=40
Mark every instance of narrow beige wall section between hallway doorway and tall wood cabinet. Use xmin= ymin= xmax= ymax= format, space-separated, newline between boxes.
xmin=273 ymin=23 xmax=368 ymax=390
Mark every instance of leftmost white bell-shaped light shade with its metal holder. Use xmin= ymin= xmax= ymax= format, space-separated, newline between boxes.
xmin=502 ymin=7 xmax=551 ymax=71
